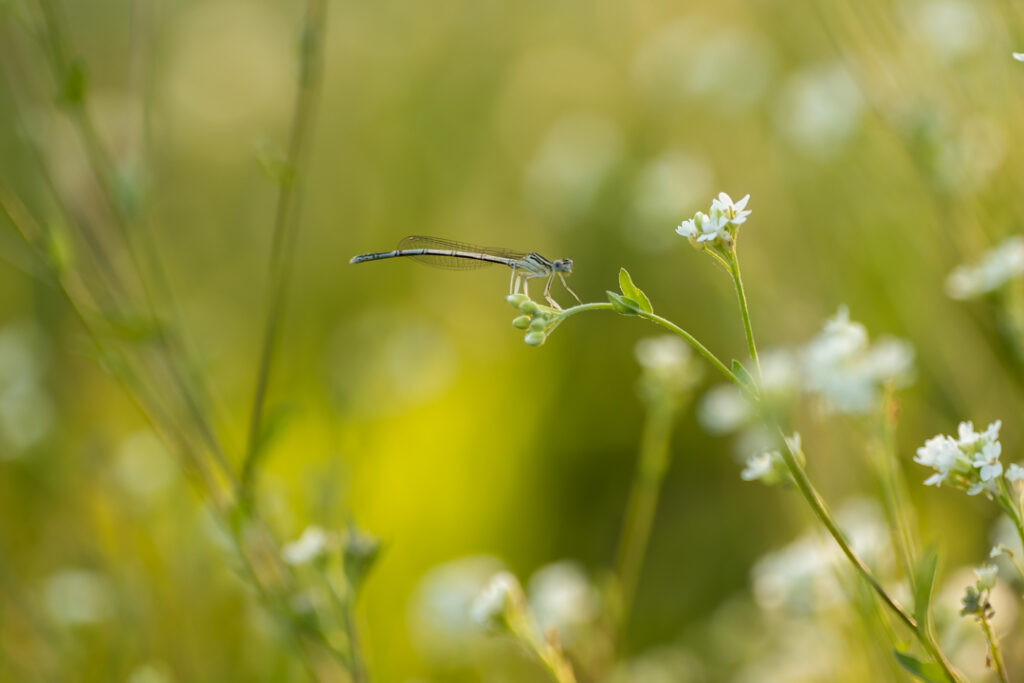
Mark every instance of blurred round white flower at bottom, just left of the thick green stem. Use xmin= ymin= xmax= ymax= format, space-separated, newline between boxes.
xmin=526 ymin=561 xmax=600 ymax=645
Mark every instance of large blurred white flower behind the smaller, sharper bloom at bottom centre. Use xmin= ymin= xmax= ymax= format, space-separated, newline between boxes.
xmin=409 ymin=555 xmax=502 ymax=666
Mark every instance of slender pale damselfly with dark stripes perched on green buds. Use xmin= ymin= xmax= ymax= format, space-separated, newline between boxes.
xmin=349 ymin=234 xmax=582 ymax=309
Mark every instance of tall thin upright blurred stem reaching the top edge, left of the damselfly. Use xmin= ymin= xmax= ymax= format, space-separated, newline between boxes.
xmin=242 ymin=0 xmax=327 ymax=497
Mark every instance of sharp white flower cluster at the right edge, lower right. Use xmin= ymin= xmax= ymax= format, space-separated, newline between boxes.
xmin=913 ymin=420 xmax=1024 ymax=498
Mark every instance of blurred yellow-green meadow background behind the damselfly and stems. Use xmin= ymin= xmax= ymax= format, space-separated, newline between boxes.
xmin=0 ymin=0 xmax=1024 ymax=683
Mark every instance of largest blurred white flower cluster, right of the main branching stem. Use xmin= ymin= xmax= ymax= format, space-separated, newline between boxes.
xmin=803 ymin=306 xmax=913 ymax=414
